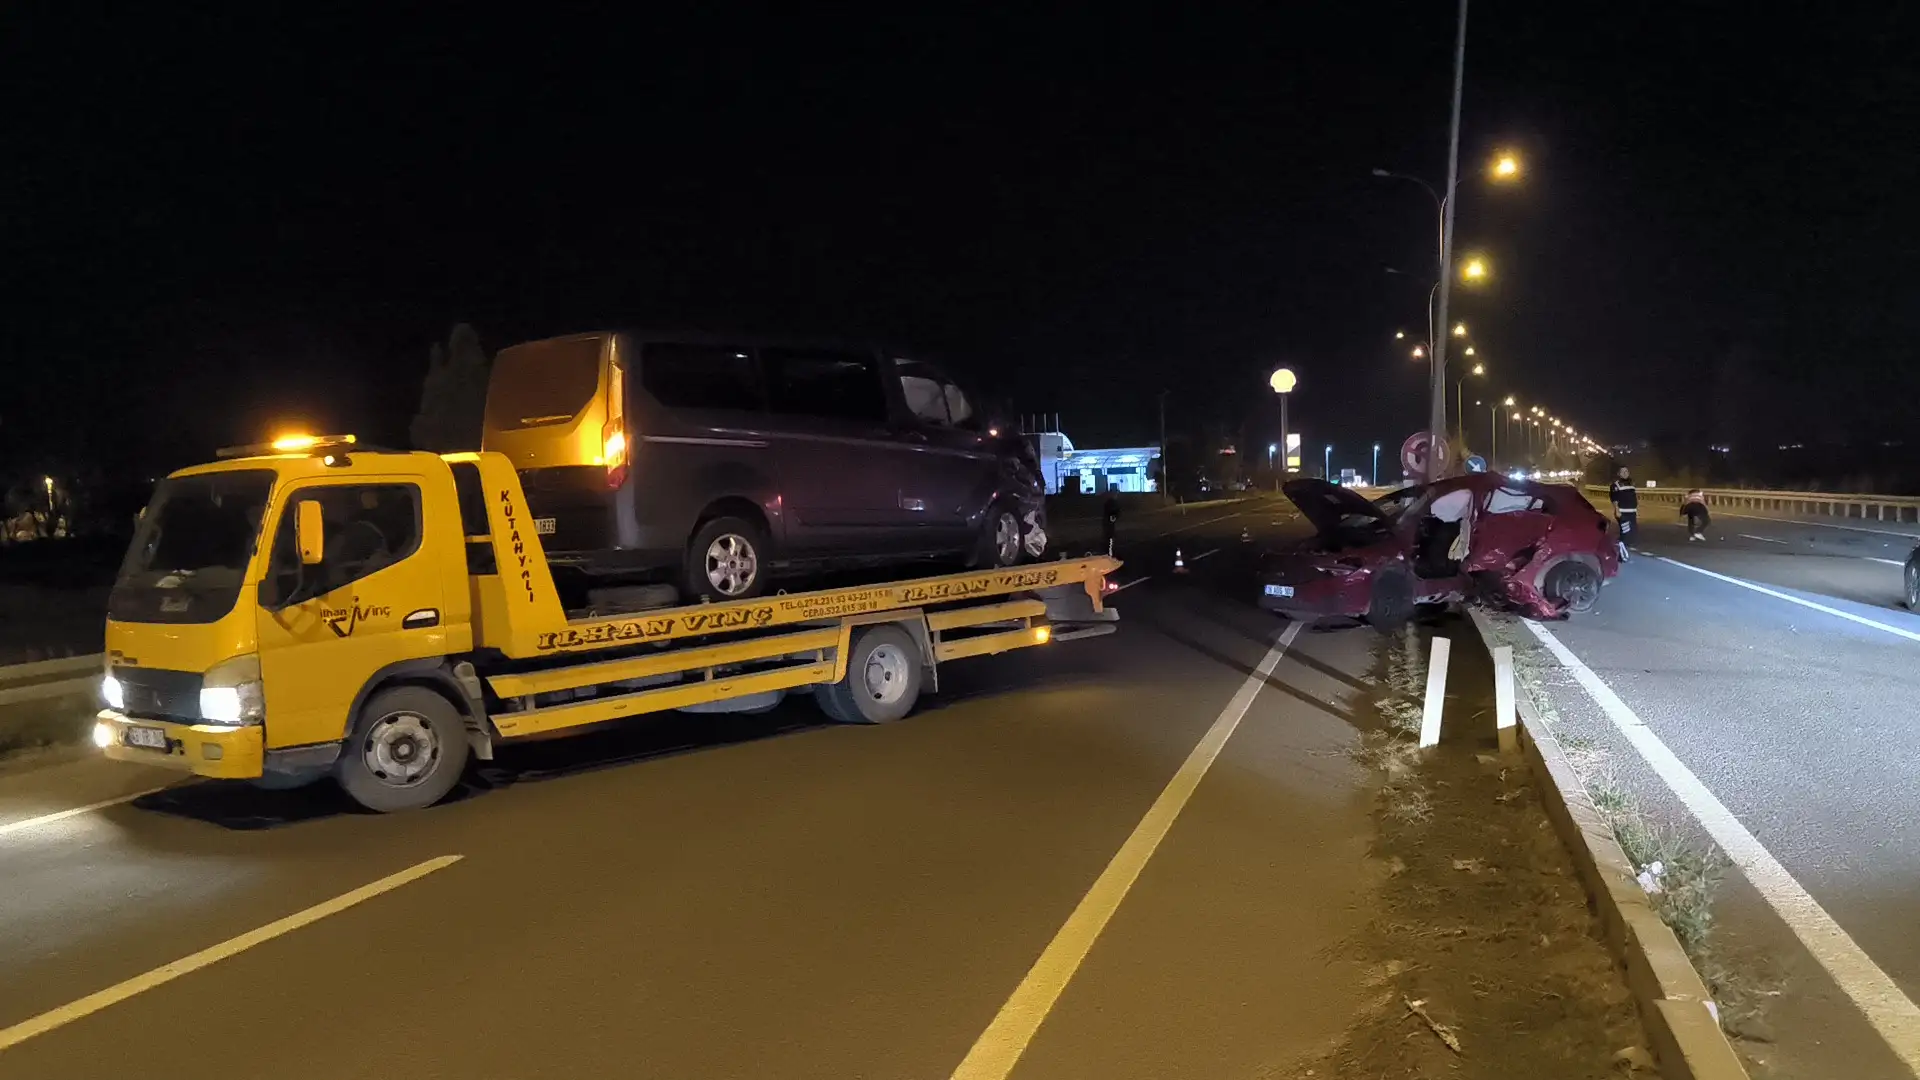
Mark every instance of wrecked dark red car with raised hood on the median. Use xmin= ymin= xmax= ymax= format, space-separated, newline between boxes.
xmin=1260 ymin=473 xmax=1620 ymax=630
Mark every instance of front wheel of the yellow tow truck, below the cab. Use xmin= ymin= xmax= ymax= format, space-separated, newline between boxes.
xmin=334 ymin=686 xmax=468 ymax=813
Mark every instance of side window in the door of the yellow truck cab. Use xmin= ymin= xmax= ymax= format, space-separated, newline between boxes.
xmin=269 ymin=484 xmax=420 ymax=600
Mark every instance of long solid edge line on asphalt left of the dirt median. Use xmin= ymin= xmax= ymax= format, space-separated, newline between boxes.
xmin=952 ymin=623 xmax=1300 ymax=1080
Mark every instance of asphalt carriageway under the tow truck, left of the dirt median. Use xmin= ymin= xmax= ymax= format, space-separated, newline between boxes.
xmin=0 ymin=502 xmax=1413 ymax=1080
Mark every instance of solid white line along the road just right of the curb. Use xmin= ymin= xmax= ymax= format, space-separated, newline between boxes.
xmin=1523 ymin=614 xmax=1920 ymax=1076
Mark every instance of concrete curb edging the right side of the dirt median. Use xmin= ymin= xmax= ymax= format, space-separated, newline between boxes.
xmin=1473 ymin=611 xmax=1747 ymax=1080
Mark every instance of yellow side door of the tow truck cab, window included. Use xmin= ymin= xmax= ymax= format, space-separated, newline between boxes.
xmin=257 ymin=475 xmax=449 ymax=748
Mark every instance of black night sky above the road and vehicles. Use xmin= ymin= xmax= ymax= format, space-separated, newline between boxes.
xmin=0 ymin=0 xmax=1920 ymax=474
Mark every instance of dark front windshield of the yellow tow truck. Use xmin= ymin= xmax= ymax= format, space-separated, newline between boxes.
xmin=108 ymin=469 xmax=275 ymax=623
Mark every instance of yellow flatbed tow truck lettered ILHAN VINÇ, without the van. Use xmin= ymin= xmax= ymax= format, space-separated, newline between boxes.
xmin=94 ymin=436 xmax=1119 ymax=811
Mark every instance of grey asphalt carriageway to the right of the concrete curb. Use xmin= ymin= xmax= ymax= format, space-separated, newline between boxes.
xmin=1520 ymin=499 xmax=1920 ymax=1078
